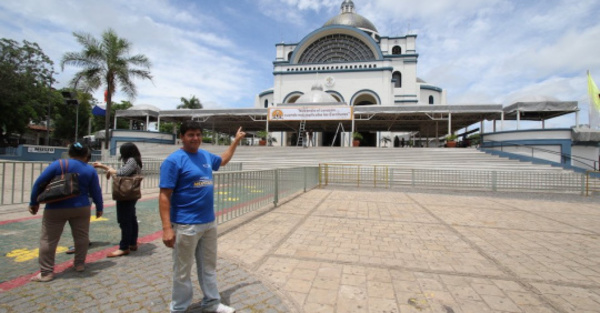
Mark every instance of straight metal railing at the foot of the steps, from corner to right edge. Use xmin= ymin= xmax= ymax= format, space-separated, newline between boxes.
xmin=319 ymin=163 xmax=600 ymax=195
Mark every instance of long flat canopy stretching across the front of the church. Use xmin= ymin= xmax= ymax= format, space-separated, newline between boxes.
xmin=116 ymin=101 xmax=579 ymax=137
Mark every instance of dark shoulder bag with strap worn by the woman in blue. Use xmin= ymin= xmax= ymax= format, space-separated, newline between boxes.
xmin=37 ymin=159 xmax=81 ymax=203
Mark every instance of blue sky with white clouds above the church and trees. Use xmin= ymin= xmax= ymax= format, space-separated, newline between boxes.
xmin=0 ymin=0 xmax=600 ymax=127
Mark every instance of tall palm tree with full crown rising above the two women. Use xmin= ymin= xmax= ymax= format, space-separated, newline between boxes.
xmin=60 ymin=28 xmax=152 ymax=149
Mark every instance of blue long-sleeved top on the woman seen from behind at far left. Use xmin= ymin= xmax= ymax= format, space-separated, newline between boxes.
xmin=29 ymin=159 xmax=104 ymax=211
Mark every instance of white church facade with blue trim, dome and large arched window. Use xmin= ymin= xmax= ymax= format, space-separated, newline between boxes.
xmin=255 ymin=0 xmax=446 ymax=146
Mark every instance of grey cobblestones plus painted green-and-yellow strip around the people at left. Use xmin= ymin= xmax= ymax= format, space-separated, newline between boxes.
xmin=0 ymin=199 xmax=295 ymax=313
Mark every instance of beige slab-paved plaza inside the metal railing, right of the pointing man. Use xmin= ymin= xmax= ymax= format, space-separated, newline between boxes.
xmin=220 ymin=188 xmax=600 ymax=313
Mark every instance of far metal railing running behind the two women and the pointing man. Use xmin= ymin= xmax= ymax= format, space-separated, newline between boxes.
xmin=0 ymin=159 xmax=242 ymax=205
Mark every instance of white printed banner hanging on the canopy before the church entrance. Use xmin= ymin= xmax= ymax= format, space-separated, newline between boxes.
xmin=269 ymin=106 xmax=353 ymax=121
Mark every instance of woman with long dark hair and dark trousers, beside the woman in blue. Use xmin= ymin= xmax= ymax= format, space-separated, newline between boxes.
xmin=94 ymin=142 xmax=142 ymax=258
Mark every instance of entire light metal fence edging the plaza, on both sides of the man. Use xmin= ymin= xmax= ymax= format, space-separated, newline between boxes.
xmin=0 ymin=160 xmax=600 ymax=207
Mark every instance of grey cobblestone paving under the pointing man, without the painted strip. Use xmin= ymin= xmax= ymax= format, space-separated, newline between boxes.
xmin=0 ymin=242 xmax=289 ymax=313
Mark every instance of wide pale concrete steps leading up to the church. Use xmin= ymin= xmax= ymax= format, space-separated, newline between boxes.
xmin=140 ymin=144 xmax=566 ymax=172
